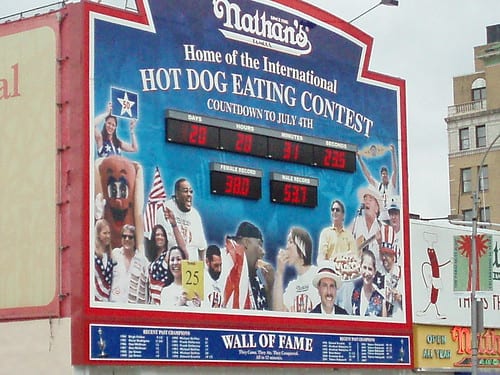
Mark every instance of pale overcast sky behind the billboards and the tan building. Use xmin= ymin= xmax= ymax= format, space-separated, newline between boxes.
xmin=0 ymin=0 xmax=500 ymax=218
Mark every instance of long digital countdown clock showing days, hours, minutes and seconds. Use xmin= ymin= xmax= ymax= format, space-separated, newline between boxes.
xmin=165 ymin=110 xmax=357 ymax=173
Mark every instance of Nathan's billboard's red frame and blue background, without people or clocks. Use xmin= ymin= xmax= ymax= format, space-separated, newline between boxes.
xmin=72 ymin=0 xmax=413 ymax=368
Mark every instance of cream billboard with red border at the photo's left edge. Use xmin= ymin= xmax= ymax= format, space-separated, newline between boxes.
xmin=0 ymin=16 xmax=58 ymax=319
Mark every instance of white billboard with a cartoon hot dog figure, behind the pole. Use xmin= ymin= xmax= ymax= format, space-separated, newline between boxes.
xmin=411 ymin=221 xmax=500 ymax=328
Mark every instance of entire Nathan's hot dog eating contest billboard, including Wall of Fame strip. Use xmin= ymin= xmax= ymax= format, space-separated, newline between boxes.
xmin=81 ymin=0 xmax=412 ymax=368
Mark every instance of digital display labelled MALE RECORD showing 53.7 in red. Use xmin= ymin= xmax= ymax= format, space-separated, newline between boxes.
xmin=270 ymin=172 xmax=319 ymax=208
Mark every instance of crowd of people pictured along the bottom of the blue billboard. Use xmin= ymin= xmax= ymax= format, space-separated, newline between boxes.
xmin=93 ymin=101 xmax=404 ymax=317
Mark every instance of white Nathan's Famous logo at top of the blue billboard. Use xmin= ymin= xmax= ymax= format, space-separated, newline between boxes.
xmin=213 ymin=0 xmax=311 ymax=56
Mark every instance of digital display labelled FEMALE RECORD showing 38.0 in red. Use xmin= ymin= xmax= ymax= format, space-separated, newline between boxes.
xmin=210 ymin=162 xmax=262 ymax=200
